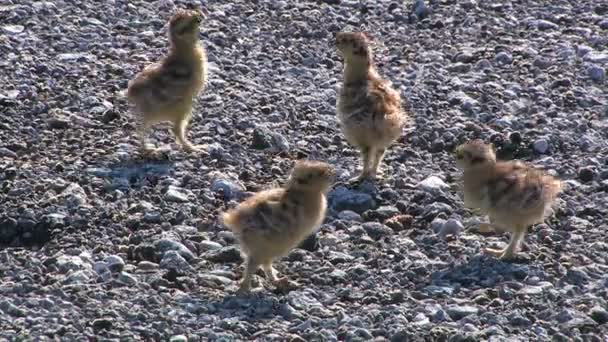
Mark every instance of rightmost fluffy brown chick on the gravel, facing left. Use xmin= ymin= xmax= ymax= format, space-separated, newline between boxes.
xmin=456 ymin=140 xmax=562 ymax=260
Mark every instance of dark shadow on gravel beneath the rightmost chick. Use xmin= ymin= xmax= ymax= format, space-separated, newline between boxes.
xmin=429 ymin=254 xmax=534 ymax=288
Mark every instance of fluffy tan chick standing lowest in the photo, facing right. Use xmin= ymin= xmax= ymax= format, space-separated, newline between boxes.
xmin=222 ymin=160 xmax=335 ymax=293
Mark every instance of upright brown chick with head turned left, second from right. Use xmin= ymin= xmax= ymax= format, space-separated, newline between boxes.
xmin=336 ymin=32 xmax=408 ymax=181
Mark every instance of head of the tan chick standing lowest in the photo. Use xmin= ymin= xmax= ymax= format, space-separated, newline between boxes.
xmin=288 ymin=160 xmax=336 ymax=192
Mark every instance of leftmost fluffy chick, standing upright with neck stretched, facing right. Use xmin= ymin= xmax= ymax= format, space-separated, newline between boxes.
xmin=126 ymin=10 xmax=207 ymax=152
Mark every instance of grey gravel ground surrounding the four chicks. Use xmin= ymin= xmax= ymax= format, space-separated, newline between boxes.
xmin=0 ymin=0 xmax=608 ymax=341
